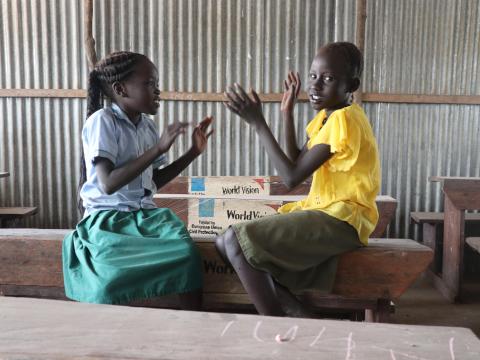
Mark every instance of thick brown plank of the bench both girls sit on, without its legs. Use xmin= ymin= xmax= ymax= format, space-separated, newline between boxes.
xmin=0 ymin=229 xmax=433 ymax=304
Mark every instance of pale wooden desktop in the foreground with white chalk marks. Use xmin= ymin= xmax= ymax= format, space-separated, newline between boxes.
xmin=0 ymin=296 xmax=480 ymax=360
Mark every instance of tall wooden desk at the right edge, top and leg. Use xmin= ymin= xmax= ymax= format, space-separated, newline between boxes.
xmin=429 ymin=176 xmax=480 ymax=302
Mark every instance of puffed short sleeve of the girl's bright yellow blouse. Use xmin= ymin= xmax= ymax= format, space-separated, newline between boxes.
xmin=308 ymin=110 xmax=361 ymax=171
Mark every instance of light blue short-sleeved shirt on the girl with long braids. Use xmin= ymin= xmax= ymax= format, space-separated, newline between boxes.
xmin=80 ymin=103 xmax=167 ymax=216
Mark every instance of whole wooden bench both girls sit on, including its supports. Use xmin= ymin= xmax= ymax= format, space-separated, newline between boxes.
xmin=0 ymin=229 xmax=433 ymax=322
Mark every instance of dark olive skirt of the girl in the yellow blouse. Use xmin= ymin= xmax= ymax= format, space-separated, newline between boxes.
xmin=232 ymin=210 xmax=363 ymax=292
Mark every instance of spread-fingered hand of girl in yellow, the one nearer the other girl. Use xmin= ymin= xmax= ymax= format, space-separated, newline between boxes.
xmin=224 ymin=83 xmax=265 ymax=125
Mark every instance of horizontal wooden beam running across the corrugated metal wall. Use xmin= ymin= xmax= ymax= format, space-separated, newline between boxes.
xmin=0 ymin=89 xmax=480 ymax=105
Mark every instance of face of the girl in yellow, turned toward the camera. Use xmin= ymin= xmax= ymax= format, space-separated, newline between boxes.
xmin=307 ymin=50 xmax=350 ymax=111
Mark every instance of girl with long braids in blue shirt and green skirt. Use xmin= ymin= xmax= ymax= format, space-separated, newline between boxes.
xmin=63 ymin=52 xmax=213 ymax=310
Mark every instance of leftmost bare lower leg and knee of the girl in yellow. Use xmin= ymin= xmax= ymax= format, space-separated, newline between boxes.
xmin=216 ymin=228 xmax=286 ymax=316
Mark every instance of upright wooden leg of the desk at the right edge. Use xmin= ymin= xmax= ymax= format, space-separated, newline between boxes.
xmin=442 ymin=193 xmax=465 ymax=302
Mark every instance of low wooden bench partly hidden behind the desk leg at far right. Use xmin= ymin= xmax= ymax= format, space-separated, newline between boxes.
xmin=410 ymin=212 xmax=480 ymax=274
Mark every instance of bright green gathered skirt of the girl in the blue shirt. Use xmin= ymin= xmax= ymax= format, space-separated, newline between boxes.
xmin=62 ymin=209 xmax=202 ymax=304
